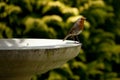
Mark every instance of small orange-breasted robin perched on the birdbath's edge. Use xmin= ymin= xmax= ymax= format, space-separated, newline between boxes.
xmin=63 ymin=16 xmax=86 ymax=41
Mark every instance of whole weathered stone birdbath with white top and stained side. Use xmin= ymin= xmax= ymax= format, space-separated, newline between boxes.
xmin=0 ymin=39 xmax=81 ymax=80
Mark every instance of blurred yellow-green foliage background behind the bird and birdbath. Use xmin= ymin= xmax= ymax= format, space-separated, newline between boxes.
xmin=0 ymin=0 xmax=120 ymax=80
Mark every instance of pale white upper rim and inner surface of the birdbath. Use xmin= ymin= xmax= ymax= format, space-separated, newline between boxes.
xmin=0 ymin=38 xmax=81 ymax=50
